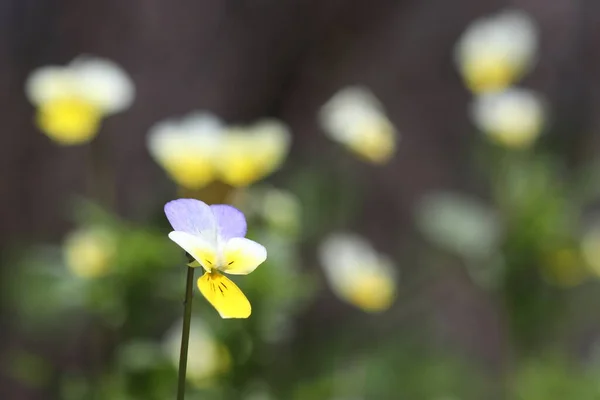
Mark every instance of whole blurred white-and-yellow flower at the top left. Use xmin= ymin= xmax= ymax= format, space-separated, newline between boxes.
xmin=26 ymin=56 xmax=135 ymax=145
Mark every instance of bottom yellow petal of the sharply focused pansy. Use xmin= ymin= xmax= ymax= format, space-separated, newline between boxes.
xmin=198 ymin=272 xmax=252 ymax=318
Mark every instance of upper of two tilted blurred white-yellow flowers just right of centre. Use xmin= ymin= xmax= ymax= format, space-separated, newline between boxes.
xmin=319 ymin=86 xmax=398 ymax=164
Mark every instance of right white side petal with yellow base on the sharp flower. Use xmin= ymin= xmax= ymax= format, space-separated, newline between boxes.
xmin=221 ymin=238 xmax=267 ymax=275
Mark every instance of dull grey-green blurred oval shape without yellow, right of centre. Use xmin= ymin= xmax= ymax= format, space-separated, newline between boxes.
xmin=415 ymin=193 xmax=501 ymax=260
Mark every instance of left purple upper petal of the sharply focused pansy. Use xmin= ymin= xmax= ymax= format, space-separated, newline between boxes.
xmin=165 ymin=199 xmax=216 ymax=235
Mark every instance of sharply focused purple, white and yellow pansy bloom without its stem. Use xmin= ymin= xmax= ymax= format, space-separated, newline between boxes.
xmin=165 ymin=199 xmax=267 ymax=318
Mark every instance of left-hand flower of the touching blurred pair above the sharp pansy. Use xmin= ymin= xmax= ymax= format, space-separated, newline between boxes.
xmin=147 ymin=112 xmax=224 ymax=189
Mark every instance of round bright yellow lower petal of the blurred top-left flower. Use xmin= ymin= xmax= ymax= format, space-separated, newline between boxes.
xmin=37 ymin=97 xmax=102 ymax=145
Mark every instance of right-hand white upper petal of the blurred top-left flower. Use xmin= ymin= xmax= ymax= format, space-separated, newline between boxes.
xmin=69 ymin=57 xmax=135 ymax=114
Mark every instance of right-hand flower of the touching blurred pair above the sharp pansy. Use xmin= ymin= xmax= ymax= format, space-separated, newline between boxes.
xmin=216 ymin=119 xmax=291 ymax=187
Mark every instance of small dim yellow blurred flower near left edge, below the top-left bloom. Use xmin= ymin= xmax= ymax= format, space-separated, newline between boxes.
xmin=63 ymin=228 xmax=116 ymax=278
